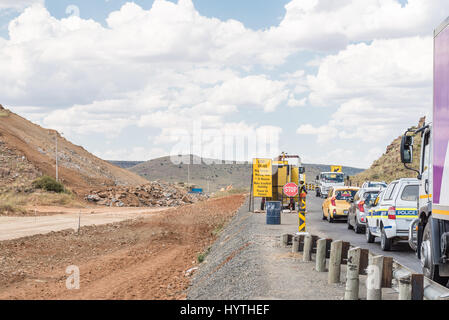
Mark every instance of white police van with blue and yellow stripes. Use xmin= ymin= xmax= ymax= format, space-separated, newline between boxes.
xmin=366 ymin=178 xmax=419 ymax=251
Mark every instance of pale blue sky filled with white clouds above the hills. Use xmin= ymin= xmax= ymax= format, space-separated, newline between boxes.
xmin=0 ymin=0 xmax=442 ymax=167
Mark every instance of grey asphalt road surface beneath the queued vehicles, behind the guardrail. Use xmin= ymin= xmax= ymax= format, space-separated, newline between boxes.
xmin=268 ymin=195 xmax=421 ymax=272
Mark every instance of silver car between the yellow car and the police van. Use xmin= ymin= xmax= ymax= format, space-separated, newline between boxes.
xmin=348 ymin=187 xmax=383 ymax=233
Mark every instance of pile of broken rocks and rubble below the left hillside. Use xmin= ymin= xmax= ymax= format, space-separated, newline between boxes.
xmin=85 ymin=181 xmax=207 ymax=207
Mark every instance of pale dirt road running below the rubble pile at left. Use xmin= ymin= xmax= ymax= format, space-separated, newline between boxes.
xmin=0 ymin=207 xmax=168 ymax=241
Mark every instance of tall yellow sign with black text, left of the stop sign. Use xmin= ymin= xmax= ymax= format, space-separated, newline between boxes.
xmin=253 ymin=159 xmax=273 ymax=198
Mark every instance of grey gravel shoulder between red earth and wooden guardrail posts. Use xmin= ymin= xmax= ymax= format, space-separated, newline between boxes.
xmin=187 ymin=198 xmax=344 ymax=300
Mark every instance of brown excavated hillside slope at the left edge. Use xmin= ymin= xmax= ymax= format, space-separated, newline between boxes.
xmin=0 ymin=105 xmax=147 ymax=194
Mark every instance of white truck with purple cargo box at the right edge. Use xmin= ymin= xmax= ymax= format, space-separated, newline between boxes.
xmin=401 ymin=18 xmax=449 ymax=285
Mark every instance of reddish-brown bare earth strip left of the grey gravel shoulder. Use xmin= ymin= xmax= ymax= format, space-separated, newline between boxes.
xmin=0 ymin=195 xmax=244 ymax=299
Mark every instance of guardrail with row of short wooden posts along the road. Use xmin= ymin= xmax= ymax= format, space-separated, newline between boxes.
xmin=281 ymin=234 xmax=449 ymax=300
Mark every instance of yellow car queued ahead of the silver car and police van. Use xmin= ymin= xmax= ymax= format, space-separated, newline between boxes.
xmin=322 ymin=187 xmax=360 ymax=223
